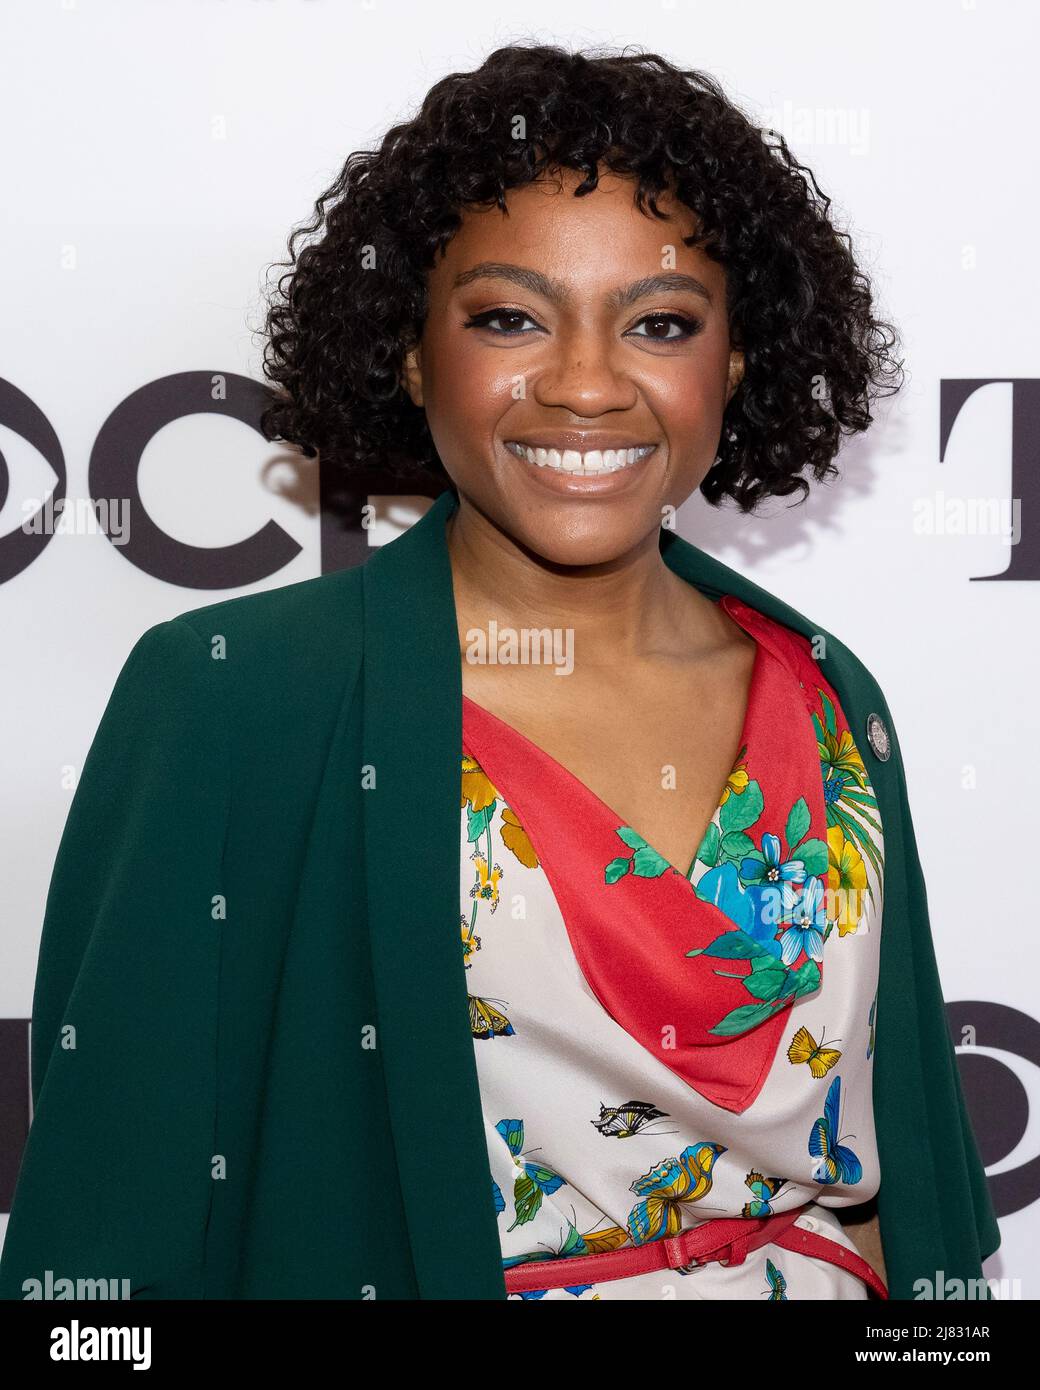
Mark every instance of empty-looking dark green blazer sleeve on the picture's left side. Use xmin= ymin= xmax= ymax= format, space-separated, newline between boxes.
xmin=0 ymin=619 xmax=229 ymax=1300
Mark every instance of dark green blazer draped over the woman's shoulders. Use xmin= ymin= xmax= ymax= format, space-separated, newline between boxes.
xmin=0 ymin=492 xmax=1000 ymax=1298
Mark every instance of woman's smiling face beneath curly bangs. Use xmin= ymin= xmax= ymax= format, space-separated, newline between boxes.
xmin=402 ymin=170 xmax=744 ymax=566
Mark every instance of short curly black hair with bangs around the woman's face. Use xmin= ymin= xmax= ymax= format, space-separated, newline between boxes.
xmin=261 ymin=44 xmax=902 ymax=512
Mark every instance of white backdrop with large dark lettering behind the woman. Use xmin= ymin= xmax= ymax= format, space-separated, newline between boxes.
xmin=0 ymin=0 xmax=1040 ymax=1298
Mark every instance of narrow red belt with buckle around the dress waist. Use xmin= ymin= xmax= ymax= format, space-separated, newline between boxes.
xmin=505 ymin=1202 xmax=888 ymax=1298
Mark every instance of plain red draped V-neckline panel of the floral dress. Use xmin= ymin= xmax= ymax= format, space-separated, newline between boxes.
xmin=463 ymin=595 xmax=845 ymax=1112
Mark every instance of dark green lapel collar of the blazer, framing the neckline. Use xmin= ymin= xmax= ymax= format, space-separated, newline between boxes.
xmin=361 ymin=491 xmax=898 ymax=1298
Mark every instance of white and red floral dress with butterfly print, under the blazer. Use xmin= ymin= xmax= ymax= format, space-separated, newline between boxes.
xmin=460 ymin=595 xmax=884 ymax=1300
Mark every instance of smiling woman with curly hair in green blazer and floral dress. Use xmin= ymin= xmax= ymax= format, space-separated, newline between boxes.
xmin=0 ymin=47 xmax=998 ymax=1300
